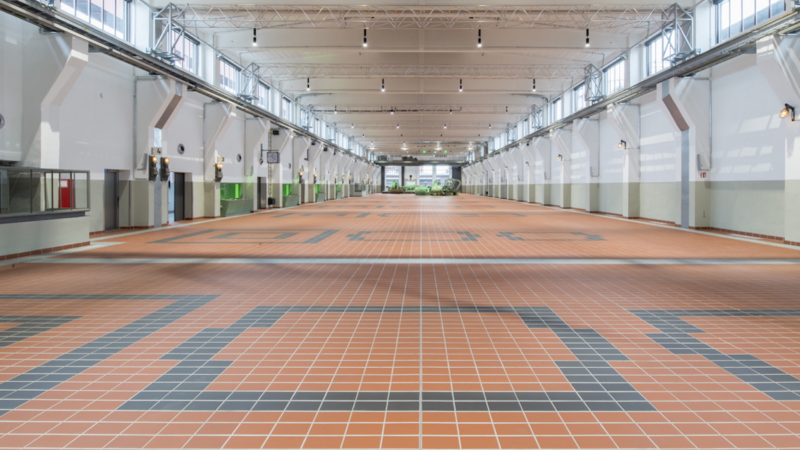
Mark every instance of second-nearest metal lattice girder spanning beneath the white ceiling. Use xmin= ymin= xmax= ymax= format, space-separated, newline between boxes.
xmin=258 ymin=63 xmax=585 ymax=80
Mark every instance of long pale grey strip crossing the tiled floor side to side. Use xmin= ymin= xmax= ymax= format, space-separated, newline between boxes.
xmin=29 ymin=258 xmax=800 ymax=266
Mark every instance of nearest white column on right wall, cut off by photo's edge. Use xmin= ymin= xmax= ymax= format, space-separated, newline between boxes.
xmin=756 ymin=36 xmax=800 ymax=244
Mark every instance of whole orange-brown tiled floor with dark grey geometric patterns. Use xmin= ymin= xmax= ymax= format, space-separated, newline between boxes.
xmin=0 ymin=195 xmax=800 ymax=449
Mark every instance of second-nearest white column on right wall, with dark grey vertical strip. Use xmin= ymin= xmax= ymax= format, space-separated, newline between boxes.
xmin=657 ymin=78 xmax=711 ymax=228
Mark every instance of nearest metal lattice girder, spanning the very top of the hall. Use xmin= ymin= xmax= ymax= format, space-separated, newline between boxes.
xmin=159 ymin=3 xmax=671 ymax=31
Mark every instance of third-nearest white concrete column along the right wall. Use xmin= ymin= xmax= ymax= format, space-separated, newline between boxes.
xmin=608 ymin=104 xmax=641 ymax=219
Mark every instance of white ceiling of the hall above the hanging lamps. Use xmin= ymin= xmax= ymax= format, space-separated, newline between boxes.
xmin=167 ymin=0 xmax=690 ymax=154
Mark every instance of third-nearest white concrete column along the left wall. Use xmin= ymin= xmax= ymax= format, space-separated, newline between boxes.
xmin=203 ymin=102 xmax=236 ymax=217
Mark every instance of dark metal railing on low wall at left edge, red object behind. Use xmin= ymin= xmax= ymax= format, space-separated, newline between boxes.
xmin=0 ymin=167 xmax=90 ymax=218
